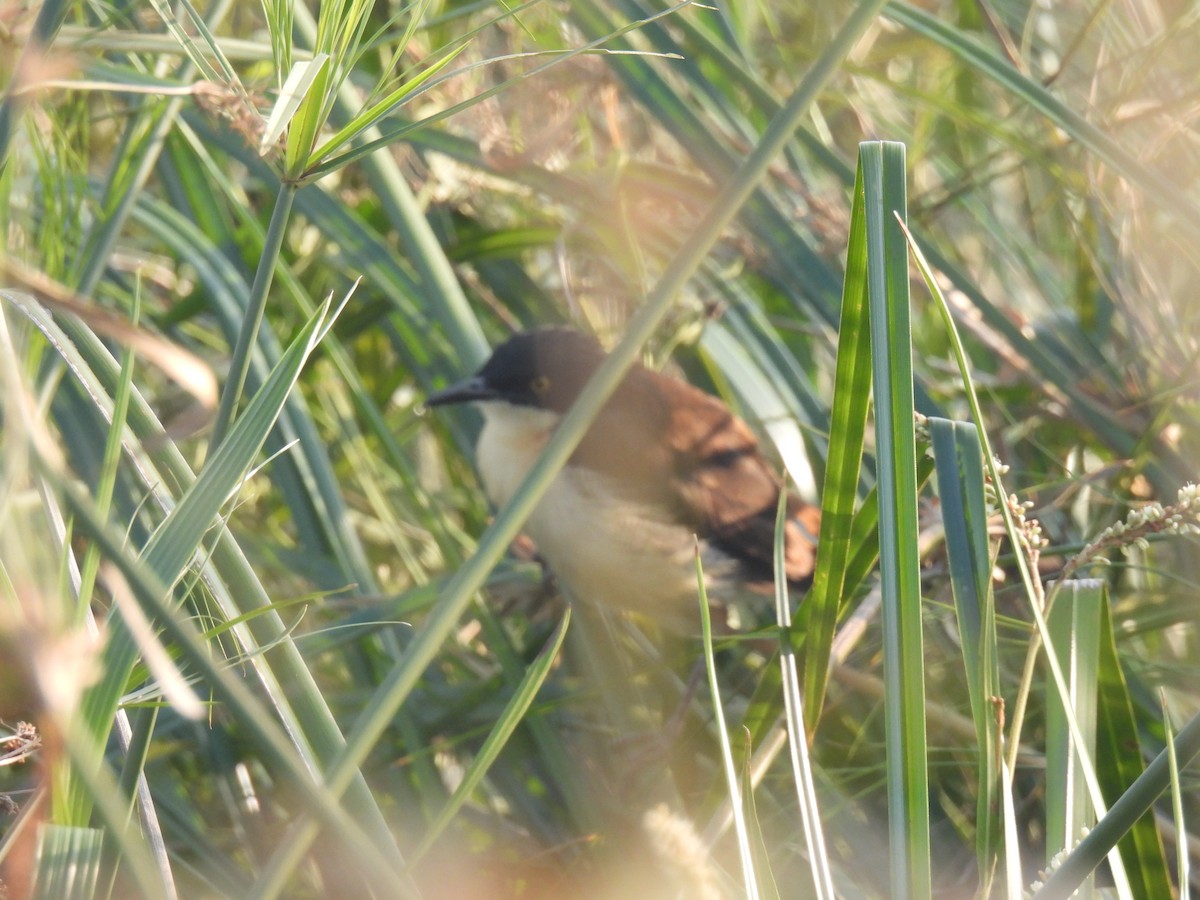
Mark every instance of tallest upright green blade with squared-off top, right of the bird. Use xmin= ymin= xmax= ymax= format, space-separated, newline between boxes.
xmin=859 ymin=137 xmax=932 ymax=898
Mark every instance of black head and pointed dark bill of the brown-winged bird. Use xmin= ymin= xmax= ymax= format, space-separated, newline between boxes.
xmin=425 ymin=328 xmax=605 ymax=413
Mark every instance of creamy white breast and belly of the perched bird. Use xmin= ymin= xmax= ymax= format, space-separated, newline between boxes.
xmin=476 ymin=402 xmax=733 ymax=622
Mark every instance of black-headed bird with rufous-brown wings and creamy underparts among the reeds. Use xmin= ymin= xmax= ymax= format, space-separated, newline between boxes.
xmin=425 ymin=326 xmax=821 ymax=631
